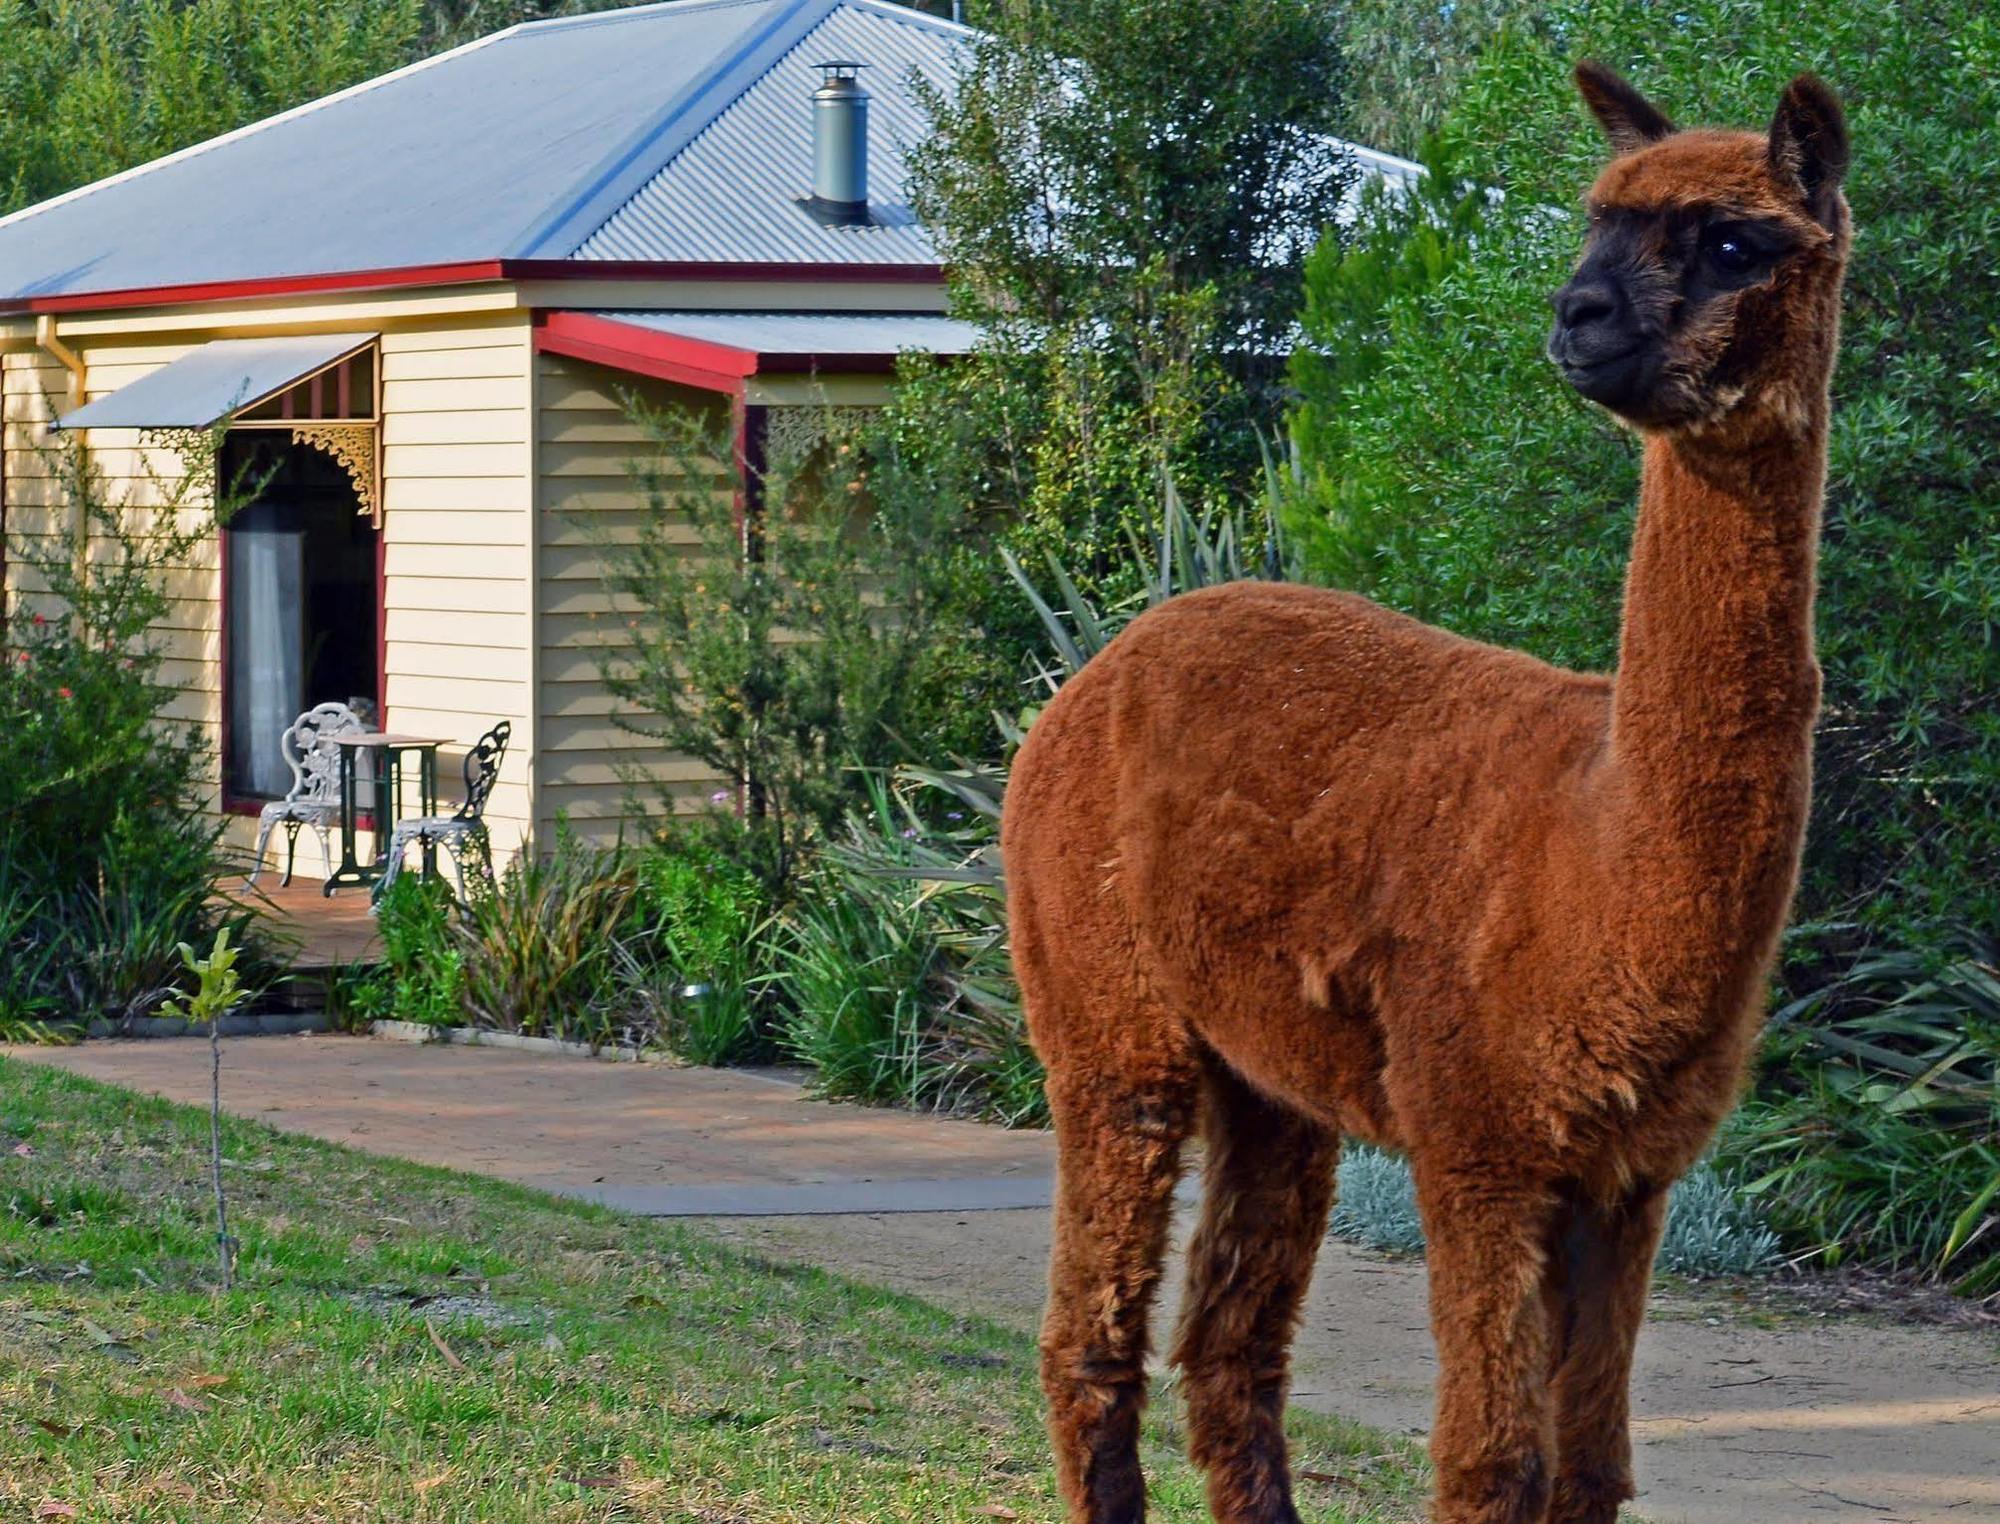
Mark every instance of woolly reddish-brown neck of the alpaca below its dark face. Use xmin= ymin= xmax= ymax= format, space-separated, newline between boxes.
xmin=1608 ymin=416 xmax=1826 ymax=908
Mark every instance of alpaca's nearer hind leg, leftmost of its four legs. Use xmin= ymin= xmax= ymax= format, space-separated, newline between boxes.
xmin=1042 ymin=1062 xmax=1196 ymax=1524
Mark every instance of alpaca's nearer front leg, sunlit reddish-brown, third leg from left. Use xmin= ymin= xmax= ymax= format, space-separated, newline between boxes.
xmin=1416 ymin=1158 xmax=1554 ymax=1524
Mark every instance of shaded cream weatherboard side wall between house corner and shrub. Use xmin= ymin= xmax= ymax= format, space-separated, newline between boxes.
xmin=536 ymin=354 xmax=728 ymax=842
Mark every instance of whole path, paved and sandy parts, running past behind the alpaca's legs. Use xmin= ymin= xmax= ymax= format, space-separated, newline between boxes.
xmin=8 ymin=1036 xmax=2000 ymax=1524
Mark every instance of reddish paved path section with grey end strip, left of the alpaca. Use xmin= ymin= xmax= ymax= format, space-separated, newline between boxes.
xmin=0 ymin=1034 xmax=1054 ymax=1216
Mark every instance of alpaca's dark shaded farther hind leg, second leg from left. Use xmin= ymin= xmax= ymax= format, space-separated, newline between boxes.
xmin=1174 ymin=1064 xmax=1340 ymax=1524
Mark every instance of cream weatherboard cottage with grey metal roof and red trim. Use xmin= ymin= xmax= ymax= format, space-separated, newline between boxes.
xmin=0 ymin=0 xmax=1408 ymax=868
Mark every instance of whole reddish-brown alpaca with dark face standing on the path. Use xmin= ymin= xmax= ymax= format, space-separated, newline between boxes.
xmin=1002 ymin=64 xmax=1848 ymax=1524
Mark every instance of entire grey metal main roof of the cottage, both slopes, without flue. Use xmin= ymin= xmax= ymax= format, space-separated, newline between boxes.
xmin=0 ymin=0 xmax=1412 ymax=300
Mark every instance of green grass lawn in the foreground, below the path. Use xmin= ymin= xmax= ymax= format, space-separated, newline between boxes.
xmin=0 ymin=1060 xmax=1424 ymax=1524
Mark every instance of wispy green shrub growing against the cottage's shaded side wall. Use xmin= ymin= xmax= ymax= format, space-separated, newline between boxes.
xmin=602 ymin=404 xmax=996 ymax=904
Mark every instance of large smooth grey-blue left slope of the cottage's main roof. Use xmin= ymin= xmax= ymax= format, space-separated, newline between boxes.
xmin=0 ymin=0 xmax=860 ymax=296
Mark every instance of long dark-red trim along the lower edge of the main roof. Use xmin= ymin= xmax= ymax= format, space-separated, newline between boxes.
xmin=0 ymin=260 xmax=944 ymax=312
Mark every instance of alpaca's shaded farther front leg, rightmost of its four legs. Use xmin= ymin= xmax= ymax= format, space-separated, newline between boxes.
xmin=1546 ymin=1186 xmax=1666 ymax=1524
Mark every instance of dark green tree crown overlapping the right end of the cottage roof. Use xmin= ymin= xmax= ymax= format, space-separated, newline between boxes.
xmin=912 ymin=0 xmax=1348 ymax=354
